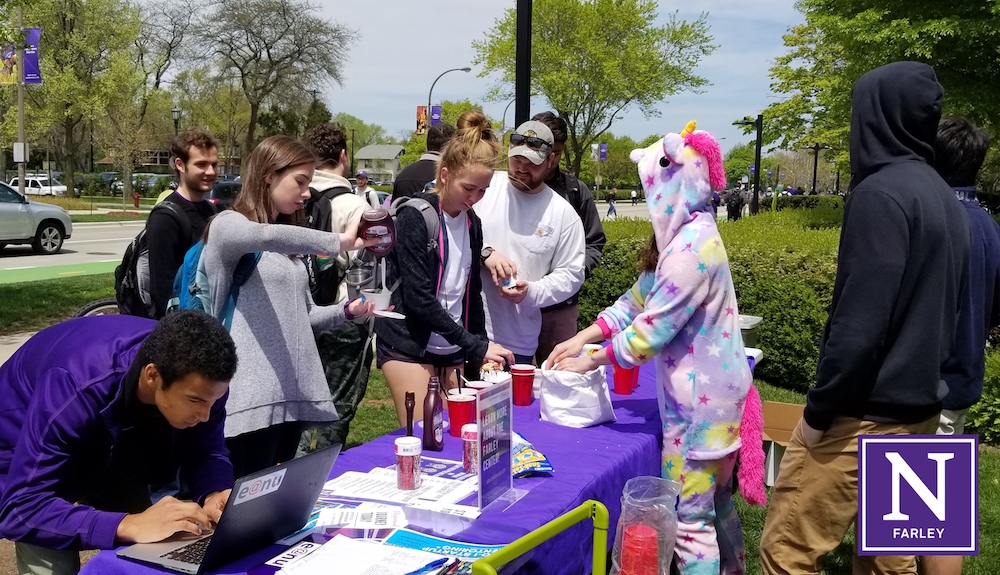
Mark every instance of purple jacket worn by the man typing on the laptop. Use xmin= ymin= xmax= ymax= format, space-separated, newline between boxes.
xmin=0 ymin=315 xmax=233 ymax=549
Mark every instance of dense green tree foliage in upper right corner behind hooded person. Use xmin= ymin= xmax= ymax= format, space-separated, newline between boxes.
xmin=764 ymin=0 xmax=1000 ymax=153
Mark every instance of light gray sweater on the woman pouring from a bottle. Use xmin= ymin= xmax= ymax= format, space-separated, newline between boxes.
xmin=204 ymin=210 xmax=346 ymax=437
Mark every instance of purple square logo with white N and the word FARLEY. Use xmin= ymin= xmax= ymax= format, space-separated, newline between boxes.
xmin=858 ymin=435 xmax=979 ymax=555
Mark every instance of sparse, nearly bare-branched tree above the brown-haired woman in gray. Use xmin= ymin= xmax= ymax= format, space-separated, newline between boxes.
xmin=199 ymin=0 xmax=357 ymax=168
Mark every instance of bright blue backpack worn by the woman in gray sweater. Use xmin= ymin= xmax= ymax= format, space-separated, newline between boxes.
xmin=167 ymin=241 xmax=261 ymax=330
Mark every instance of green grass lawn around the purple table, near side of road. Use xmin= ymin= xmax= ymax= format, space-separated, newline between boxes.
xmin=0 ymin=282 xmax=1000 ymax=575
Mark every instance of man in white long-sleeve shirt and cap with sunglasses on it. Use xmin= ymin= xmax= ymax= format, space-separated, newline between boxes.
xmin=475 ymin=121 xmax=586 ymax=363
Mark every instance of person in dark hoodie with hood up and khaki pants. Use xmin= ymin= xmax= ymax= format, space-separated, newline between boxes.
xmin=760 ymin=62 xmax=969 ymax=574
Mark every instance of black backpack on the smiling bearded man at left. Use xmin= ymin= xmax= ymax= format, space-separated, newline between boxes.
xmin=115 ymin=200 xmax=191 ymax=319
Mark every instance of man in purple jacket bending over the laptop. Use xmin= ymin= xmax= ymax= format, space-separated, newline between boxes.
xmin=0 ymin=311 xmax=236 ymax=574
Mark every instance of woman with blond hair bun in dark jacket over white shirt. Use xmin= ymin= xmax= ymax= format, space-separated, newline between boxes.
xmin=375 ymin=110 xmax=514 ymax=425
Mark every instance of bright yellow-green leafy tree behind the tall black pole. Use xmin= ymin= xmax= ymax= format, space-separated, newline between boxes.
xmin=473 ymin=0 xmax=716 ymax=176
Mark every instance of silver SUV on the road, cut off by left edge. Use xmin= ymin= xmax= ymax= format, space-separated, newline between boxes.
xmin=0 ymin=183 xmax=73 ymax=254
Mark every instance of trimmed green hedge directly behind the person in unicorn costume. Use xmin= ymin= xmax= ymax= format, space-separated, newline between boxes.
xmin=578 ymin=206 xmax=843 ymax=392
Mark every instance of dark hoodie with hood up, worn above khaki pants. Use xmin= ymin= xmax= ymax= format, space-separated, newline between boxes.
xmin=805 ymin=62 xmax=969 ymax=430
